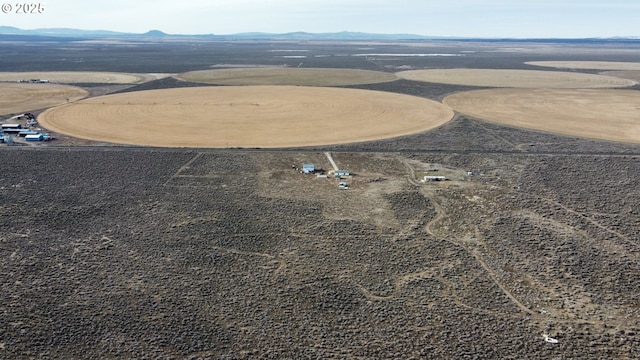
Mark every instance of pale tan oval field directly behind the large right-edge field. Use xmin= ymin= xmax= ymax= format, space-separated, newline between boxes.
xmin=396 ymin=69 xmax=637 ymax=89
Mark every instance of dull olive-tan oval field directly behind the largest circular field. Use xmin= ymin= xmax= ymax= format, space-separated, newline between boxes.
xmin=175 ymin=67 xmax=398 ymax=86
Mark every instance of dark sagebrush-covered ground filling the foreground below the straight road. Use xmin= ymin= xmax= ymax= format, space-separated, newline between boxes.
xmin=0 ymin=145 xmax=640 ymax=359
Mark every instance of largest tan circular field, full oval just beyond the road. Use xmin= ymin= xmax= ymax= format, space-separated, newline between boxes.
xmin=38 ymin=86 xmax=454 ymax=148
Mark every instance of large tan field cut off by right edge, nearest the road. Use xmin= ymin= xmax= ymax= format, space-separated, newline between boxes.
xmin=444 ymin=89 xmax=640 ymax=143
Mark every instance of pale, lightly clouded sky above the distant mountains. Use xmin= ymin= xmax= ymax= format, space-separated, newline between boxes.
xmin=0 ymin=0 xmax=640 ymax=38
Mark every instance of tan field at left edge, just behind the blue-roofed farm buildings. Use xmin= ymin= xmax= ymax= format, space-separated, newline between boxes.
xmin=0 ymin=83 xmax=89 ymax=115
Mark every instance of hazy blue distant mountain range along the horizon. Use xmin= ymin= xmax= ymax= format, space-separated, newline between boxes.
xmin=0 ymin=26 xmax=640 ymax=41
